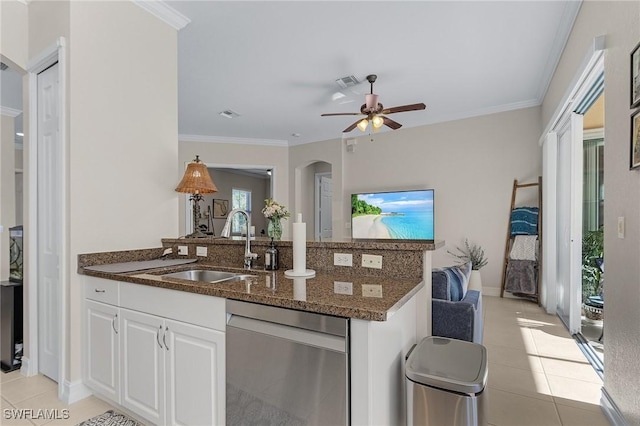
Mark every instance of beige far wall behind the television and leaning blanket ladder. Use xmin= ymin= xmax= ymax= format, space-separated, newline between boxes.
xmin=291 ymin=108 xmax=542 ymax=292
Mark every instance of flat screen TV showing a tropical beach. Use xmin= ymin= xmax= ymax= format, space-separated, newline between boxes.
xmin=351 ymin=189 xmax=435 ymax=241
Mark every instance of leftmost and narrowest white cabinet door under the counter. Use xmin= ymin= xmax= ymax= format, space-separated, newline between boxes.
xmin=86 ymin=300 xmax=120 ymax=403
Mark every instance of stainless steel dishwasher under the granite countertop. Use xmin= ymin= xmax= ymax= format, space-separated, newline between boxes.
xmin=226 ymin=300 xmax=349 ymax=426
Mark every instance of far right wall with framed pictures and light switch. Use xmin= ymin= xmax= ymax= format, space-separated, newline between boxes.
xmin=542 ymin=1 xmax=640 ymax=424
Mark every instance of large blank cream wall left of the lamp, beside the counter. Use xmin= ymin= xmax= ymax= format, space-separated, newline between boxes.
xmin=25 ymin=1 xmax=178 ymax=383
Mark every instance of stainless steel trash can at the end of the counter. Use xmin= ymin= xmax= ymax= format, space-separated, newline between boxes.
xmin=406 ymin=337 xmax=487 ymax=426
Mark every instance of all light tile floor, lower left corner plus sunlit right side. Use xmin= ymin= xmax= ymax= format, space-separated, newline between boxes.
xmin=0 ymin=297 xmax=609 ymax=426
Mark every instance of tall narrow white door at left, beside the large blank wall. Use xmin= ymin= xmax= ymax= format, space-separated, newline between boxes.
xmin=37 ymin=64 xmax=62 ymax=381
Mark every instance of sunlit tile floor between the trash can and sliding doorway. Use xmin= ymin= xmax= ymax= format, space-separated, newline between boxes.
xmin=483 ymin=297 xmax=609 ymax=426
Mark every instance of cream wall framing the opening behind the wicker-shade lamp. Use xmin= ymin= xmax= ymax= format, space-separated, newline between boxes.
xmin=180 ymin=140 xmax=291 ymax=238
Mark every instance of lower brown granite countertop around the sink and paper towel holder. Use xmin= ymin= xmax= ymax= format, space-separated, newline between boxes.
xmin=79 ymin=262 xmax=423 ymax=321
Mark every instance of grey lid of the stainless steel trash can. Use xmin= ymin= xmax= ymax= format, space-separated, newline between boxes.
xmin=406 ymin=336 xmax=487 ymax=394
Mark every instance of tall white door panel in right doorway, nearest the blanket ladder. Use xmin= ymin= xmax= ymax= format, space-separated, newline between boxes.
xmin=556 ymin=113 xmax=583 ymax=334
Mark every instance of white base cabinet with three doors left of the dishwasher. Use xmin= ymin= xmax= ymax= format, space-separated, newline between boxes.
xmin=85 ymin=277 xmax=226 ymax=425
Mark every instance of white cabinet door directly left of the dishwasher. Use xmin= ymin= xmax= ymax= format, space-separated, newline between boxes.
xmin=165 ymin=320 xmax=226 ymax=425
